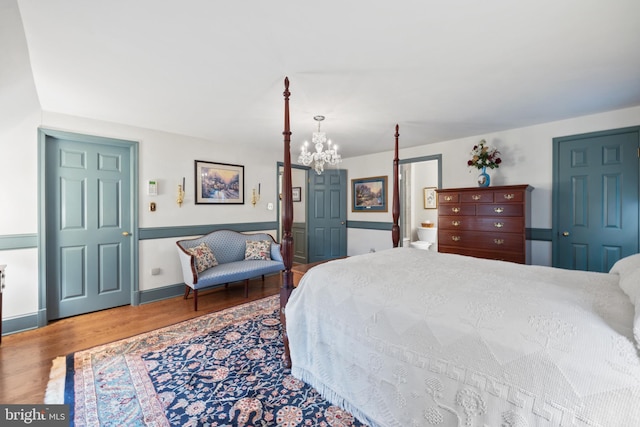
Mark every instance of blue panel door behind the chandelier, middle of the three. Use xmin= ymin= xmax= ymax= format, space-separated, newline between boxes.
xmin=307 ymin=169 xmax=347 ymax=262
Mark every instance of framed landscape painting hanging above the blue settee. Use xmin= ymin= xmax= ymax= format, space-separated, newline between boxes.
xmin=195 ymin=160 xmax=244 ymax=205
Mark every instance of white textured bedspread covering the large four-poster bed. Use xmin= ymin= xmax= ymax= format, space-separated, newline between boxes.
xmin=286 ymin=248 xmax=640 ymax=427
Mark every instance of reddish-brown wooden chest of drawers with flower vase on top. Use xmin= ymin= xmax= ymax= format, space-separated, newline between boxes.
xmin=437 ymin=185 xmax=533 ymax=264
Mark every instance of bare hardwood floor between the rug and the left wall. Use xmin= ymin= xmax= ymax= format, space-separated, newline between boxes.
xmin=0 ymin=275 xmax=281 ymax=404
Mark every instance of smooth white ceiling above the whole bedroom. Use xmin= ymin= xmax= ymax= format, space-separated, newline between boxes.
xmin=17 ymin=0 xmax=640 ymax=161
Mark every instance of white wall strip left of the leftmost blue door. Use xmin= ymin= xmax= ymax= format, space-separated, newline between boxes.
xmin=0 ymin=2 xmax=45 ymax=319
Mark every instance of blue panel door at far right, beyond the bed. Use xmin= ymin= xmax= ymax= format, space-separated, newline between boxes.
xmin=553 ymin=127 xmax=640 ymax=272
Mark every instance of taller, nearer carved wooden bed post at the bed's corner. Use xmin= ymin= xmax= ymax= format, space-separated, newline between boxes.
xmin=280 ymin=77 xmax=293 ymax=368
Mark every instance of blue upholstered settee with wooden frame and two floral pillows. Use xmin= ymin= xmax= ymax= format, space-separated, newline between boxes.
xmin=176 ymin=230 xmax=284 ymax=311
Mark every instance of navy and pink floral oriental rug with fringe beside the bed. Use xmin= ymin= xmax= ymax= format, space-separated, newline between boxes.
xmin=47 ymin=296 xmax=363 ymax=427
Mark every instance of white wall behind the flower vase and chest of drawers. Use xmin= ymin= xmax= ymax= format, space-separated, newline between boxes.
xmin=342 ymin=106 xmax=640 ymax=265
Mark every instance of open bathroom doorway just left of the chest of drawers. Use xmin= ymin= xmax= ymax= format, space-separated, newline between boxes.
xmin=399 ymin=154 xmax=442 ymax=251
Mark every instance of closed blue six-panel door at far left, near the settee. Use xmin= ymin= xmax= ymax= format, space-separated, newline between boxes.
xmin=44 ymin=132 xmax=136 ymax=320
